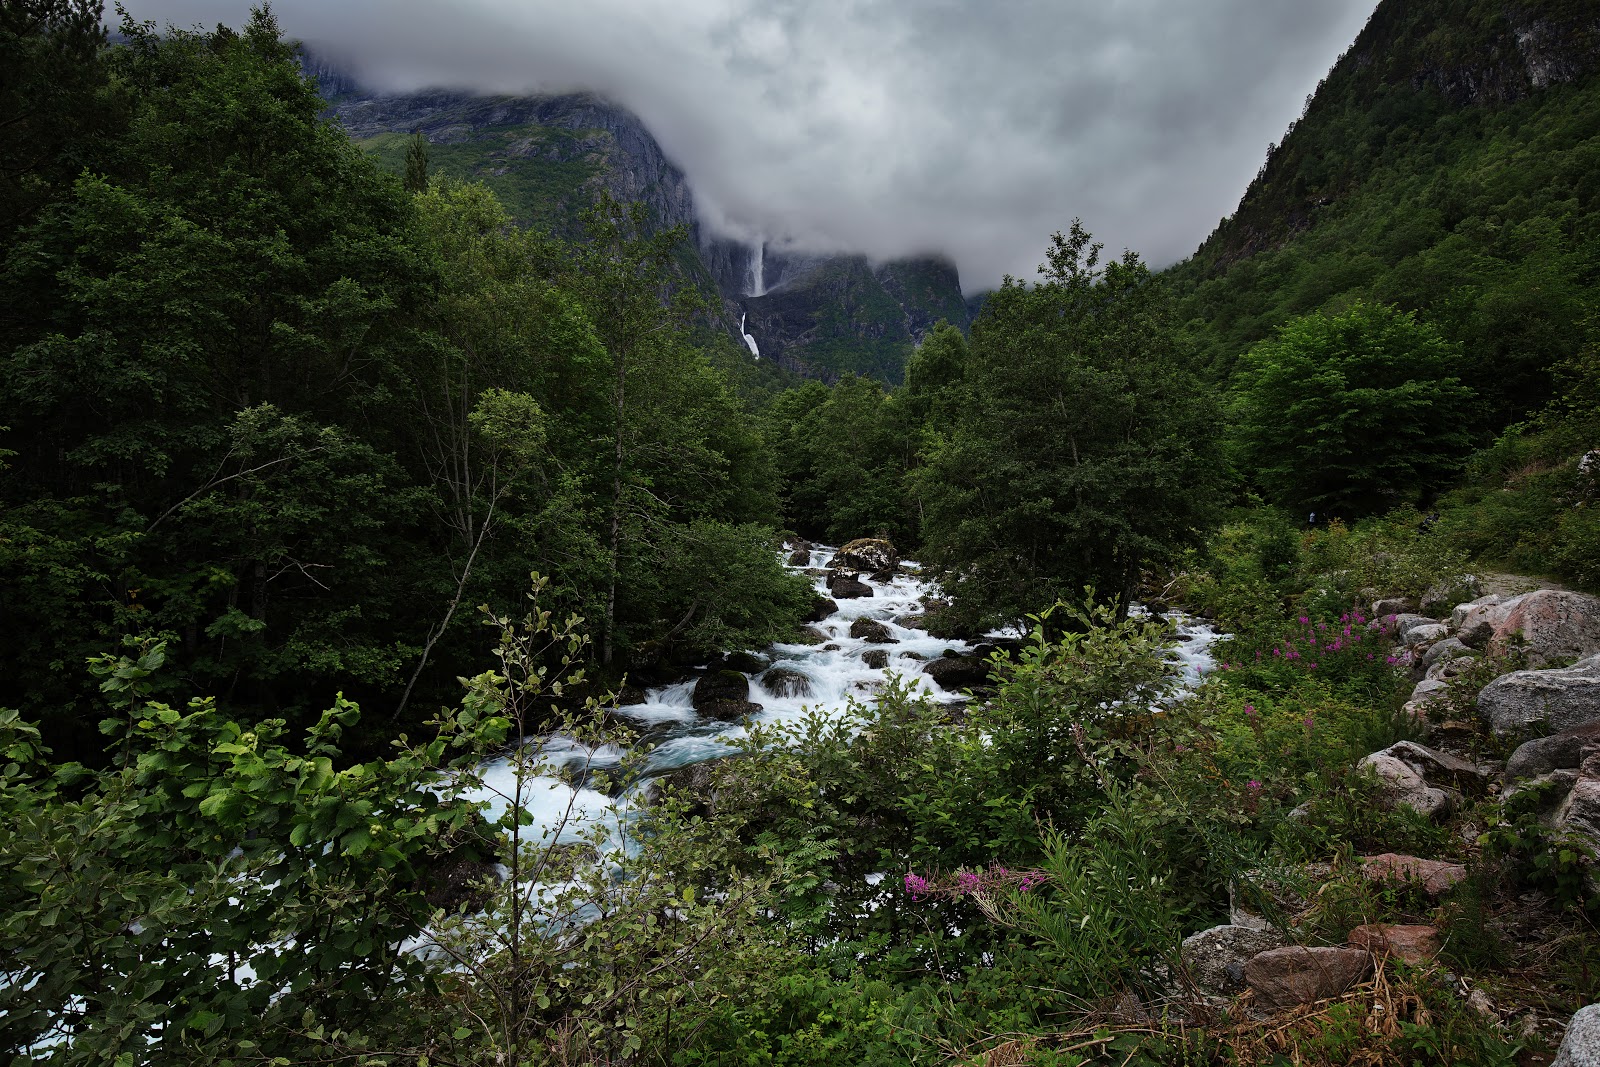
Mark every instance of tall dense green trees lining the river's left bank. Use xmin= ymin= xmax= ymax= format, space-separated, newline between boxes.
xmin=0 ymin=18 xmax=805 ymax=760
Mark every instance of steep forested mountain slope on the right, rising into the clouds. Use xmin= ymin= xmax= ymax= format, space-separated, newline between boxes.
xmin=1166 ymin=0 xmax=1600 ymax=432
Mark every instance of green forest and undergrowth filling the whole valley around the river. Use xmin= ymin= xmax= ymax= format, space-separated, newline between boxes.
xmin=0 ymin=0 xmax=1600 ymax=1067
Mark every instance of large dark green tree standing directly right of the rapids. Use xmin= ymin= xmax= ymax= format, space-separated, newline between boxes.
xmin=912 ymin=222 xmax=1222 ymax=622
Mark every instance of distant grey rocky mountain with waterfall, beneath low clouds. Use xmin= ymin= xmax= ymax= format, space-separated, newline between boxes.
xmin=304 ymin=56 xmax=971 ymax=384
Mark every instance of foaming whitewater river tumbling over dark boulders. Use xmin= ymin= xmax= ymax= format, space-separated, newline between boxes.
xmin=478 ymin=545 xmax=1218 ymax=840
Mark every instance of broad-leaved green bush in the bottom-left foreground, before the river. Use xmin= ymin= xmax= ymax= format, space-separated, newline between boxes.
xmin=0 ymin=640 xmax=489 ymax=1062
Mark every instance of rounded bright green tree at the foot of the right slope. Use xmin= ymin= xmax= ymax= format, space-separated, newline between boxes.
xmin=1234 ymin=302 xmax=1474 ymax=517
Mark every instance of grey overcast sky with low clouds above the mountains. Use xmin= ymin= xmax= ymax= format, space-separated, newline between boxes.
xmin=128 ymin=0 xmax=1376 ymax=291
